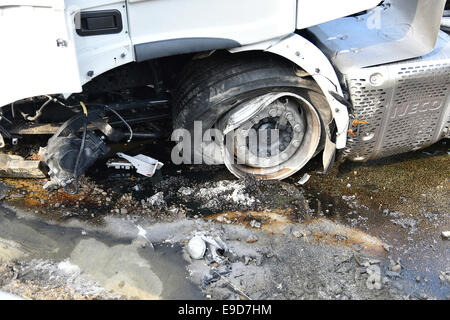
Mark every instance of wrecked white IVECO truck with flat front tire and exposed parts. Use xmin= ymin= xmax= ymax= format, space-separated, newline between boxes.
xmin=0 ymin=0 xmax=450 ymax=191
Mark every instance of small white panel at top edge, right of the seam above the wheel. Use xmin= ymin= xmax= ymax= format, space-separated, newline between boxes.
xmin=297 ymin=0 xmax=381 ymax=29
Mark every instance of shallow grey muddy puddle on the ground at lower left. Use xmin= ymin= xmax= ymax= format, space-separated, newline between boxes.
xmin=0 ymin=207 xmax=203 ymax=299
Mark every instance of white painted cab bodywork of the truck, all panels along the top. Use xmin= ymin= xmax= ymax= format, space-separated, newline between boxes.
xmin=0 ymin=0 xmax=384 ymax=106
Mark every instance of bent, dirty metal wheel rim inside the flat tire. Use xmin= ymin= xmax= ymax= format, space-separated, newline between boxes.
xmin=216 ymin=92 xmax=321 ymax=180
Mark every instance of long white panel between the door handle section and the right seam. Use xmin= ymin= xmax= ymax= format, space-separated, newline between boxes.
xmin=128 ymin=0 xmax=296 ymax=45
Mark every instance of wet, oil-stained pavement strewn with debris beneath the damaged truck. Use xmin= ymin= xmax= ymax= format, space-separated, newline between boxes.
xmin=0 ymin=140 xmax=450 ymax=299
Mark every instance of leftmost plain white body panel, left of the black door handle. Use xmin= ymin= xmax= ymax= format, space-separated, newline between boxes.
xmin=0 ymin=0 xmax=81 ymax=106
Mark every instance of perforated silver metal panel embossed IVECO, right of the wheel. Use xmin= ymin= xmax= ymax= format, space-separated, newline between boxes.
xmin=344 ymin=37 xmax=450 ymax=161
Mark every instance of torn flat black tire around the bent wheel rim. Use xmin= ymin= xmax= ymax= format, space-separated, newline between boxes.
xmin=173 ymin=52 xmax=330 ymax=179
